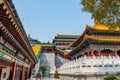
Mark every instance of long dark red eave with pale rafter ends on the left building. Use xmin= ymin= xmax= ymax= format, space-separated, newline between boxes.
xmin=0 ymin=0 xmax=37 ymax=64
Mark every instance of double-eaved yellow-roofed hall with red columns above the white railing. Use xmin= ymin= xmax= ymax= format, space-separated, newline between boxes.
xmin=68 ymin=24 xmax=120 ymax=59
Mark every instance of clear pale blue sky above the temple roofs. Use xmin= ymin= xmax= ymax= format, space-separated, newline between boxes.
xmin=13 ymin=0 xmax=93 ymax=42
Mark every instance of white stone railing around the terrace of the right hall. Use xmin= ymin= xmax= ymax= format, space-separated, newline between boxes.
xmin=58 ymin=56 xmax=120 ymax=74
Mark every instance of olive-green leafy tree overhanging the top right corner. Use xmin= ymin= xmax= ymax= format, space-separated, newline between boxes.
xmin=81 ymin=0 xmax=120 ymax=30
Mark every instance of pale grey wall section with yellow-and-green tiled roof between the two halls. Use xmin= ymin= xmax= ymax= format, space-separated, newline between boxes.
xmin=32 ymin=43 xmax=56 ymax=77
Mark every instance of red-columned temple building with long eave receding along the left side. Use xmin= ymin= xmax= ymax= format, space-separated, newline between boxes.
xmin=0 ymin=0 xmax=37 ymax=80
